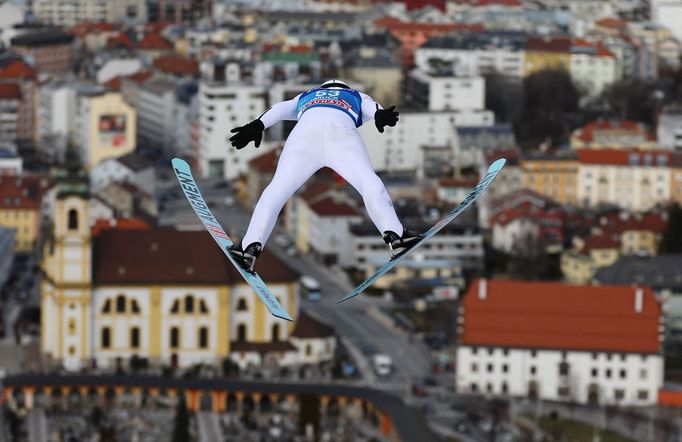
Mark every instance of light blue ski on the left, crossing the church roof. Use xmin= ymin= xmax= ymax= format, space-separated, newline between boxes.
xmin=172 ymin=158 xmax=293 ymax=321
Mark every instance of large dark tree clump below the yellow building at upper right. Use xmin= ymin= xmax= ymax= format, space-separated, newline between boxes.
xmin=515 ymin=69 xmax=580 ymax=147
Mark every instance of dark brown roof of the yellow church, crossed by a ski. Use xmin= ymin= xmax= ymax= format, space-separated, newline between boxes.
xmin=92 ymin=229 xmax=299 ymax=285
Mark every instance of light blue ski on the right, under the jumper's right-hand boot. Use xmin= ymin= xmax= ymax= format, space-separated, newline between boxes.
xmin=338 ymin=158 xmax=506 ymax=303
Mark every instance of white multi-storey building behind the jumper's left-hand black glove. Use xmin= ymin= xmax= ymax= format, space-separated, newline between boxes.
xmin=199 ymin=82 xmax=266 ymax=179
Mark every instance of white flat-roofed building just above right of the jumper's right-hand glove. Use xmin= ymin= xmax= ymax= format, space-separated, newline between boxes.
xmin=405 ymin=69 xmax=485 ymax=112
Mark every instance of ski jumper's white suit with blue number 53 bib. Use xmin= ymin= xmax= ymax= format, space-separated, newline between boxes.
xmin=242 ymin=88 xmax=403 ymax=247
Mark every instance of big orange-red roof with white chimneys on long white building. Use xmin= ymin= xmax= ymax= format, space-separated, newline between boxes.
xmin=460 ymin=280 xmax=661 ymax=353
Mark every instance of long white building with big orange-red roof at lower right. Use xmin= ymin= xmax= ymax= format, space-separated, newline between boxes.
xmin=455 ymin=279 xmax=664 ymax=406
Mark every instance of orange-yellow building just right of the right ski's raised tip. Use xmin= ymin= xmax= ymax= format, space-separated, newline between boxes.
xmin=521 ymin=152 xmax=578 ymax=205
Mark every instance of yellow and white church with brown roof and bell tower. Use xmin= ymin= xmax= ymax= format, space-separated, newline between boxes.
xmin=41 ymin=170 xmax=334 ymax=370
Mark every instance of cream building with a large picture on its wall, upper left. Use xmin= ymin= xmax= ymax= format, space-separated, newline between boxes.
xmin=77 ymin=92 xmax=137 ymax=170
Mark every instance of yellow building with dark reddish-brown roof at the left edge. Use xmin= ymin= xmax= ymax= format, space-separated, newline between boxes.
xmin=0 ymin=176 xmax=48 ymax=252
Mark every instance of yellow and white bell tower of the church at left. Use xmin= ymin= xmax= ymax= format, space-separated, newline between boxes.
xmin=41 ymin=151 xmax=92 ymax=370
